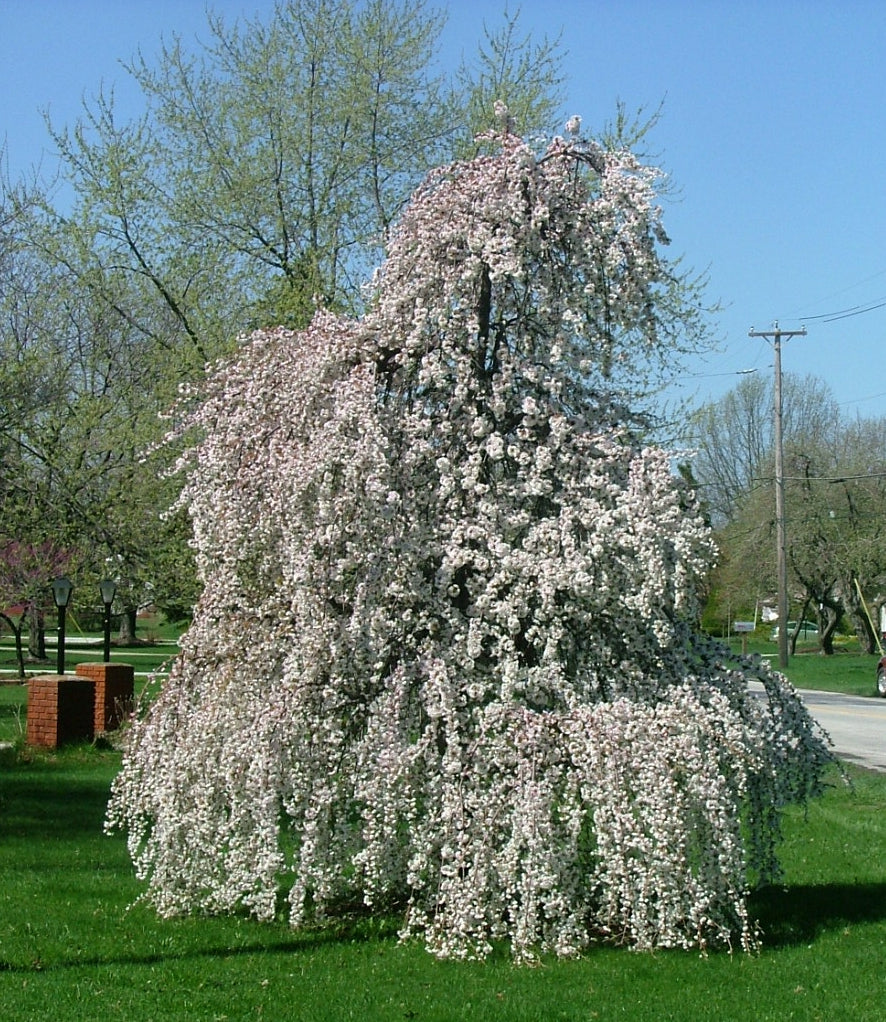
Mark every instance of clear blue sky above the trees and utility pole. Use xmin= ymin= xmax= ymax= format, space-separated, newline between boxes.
xmin=0 ymin=0 xmax=886 ymax=417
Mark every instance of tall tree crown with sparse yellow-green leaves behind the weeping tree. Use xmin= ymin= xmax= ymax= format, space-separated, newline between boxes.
xmin=43 ymin=0 xmax=437 ymax=355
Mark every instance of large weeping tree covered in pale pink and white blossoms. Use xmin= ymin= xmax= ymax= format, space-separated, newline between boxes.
xmin=108 ymin=122 xmax=830 ymax=960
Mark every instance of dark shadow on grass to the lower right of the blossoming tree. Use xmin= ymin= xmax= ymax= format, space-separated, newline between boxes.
xmin=748 ymin=883 xmax=886 ymax=948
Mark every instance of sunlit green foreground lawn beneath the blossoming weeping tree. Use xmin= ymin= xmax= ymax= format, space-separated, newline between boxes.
xmin=0 ymin=746 xmax=886 ymax=1022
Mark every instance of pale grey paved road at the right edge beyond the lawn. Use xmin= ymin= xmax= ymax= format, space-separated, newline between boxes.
xmin=800 ymin=681 xmax=886 ymax=773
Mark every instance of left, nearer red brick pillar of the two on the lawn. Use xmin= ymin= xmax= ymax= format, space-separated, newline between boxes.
xmin=27 ymin=675 xmax=95 ymax=749
